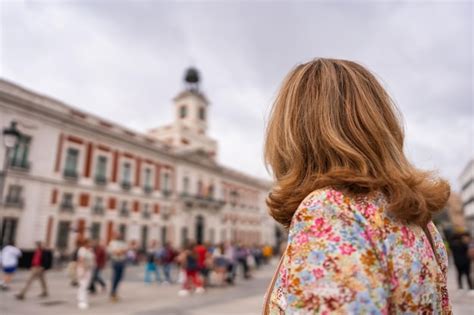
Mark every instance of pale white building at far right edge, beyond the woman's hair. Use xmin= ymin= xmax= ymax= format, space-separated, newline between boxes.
xmin=459 ymin=159 xmax=474 ymax=235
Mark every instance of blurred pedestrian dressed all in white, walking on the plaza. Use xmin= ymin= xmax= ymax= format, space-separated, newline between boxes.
xmin=76 ymin=239 xmax=95 ymax=310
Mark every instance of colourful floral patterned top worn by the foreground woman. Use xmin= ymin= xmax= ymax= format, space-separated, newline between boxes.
xmin=268 ymin=189 xmax=452 ymax=315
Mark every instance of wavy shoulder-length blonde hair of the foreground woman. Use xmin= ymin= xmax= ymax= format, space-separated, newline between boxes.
xmin=265 ymin=58 xmax=450 ymax=227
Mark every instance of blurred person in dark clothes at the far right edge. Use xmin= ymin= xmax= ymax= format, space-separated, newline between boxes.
xmin=449 ymin=233 xmax=474 ymax=292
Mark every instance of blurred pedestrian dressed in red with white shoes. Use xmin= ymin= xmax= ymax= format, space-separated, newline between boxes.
xmin=178 ymin=242 xmax=205 ymax=296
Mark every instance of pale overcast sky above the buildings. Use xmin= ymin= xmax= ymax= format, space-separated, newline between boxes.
xmin=0 ymin=0 xmax=474 ymax=190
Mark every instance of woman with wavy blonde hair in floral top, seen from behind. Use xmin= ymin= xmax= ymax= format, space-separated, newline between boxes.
xmin=264 ymin=59 xmax=451 ymax=314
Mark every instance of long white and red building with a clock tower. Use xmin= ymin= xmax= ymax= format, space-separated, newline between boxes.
xmin=0 ymin=70 xmax=279 ymax=251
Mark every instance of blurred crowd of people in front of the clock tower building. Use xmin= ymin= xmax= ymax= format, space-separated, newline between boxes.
xmin=0 ymin=233 xmax=273 ymax=309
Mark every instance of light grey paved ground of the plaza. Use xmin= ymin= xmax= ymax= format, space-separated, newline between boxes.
xmin=0 ymin=265 xmax=474 ymax=315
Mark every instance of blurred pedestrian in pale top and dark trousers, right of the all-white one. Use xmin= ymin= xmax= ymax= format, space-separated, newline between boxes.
xmin=107 ymin=233 xmax=127 ymax=302
